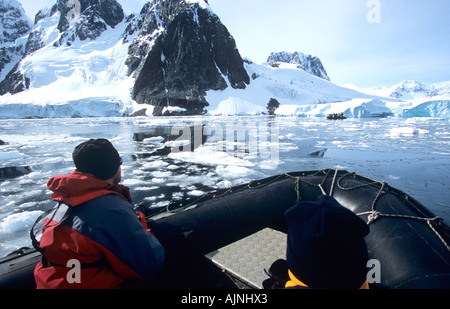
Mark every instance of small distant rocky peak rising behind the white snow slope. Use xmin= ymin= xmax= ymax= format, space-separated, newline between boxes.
xmin=267 ymin=52 xmax=330 ymax=81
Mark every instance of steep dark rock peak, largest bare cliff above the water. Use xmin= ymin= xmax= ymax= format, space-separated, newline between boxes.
xmin=126 ymin=0 xmax=250 ymax=115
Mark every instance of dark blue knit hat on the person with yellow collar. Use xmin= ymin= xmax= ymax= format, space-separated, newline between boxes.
xmin=285 ymin=196 xmax=369 ymax=289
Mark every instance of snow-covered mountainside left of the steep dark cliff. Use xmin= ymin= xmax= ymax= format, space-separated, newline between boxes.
xmin=0 ymin=0 xmax=136 ymax=118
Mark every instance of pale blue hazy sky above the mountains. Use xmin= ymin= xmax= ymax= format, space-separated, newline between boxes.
xmin=19 ymin=0 xmax=450 ymax=88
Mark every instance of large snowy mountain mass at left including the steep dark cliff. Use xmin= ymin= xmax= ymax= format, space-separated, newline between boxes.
xmin=0 ymin=0 xmax=250 ymax=117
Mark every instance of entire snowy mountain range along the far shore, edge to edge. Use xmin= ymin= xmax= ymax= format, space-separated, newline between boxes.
xmin=0 ymin=0 xmax=450 ymax=118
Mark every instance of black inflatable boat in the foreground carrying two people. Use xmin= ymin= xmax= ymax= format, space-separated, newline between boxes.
xmin=0 ymin=170 xmax=450 ymax=289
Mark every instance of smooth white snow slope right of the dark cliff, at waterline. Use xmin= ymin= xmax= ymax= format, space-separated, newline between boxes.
xmin=206 ymin=60 xmax=395 ymax=116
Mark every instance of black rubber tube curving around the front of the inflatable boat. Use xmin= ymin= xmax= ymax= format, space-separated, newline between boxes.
xmin=149 ymin=170 xmax=450 ymax=289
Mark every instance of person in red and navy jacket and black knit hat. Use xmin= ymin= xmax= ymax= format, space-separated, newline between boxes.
xmin=34 ymin=139 xmax=164 ymax=289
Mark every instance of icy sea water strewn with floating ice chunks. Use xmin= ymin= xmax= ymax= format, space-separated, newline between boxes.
xmin=0 ymin=116 xmax=450 ymax=257
